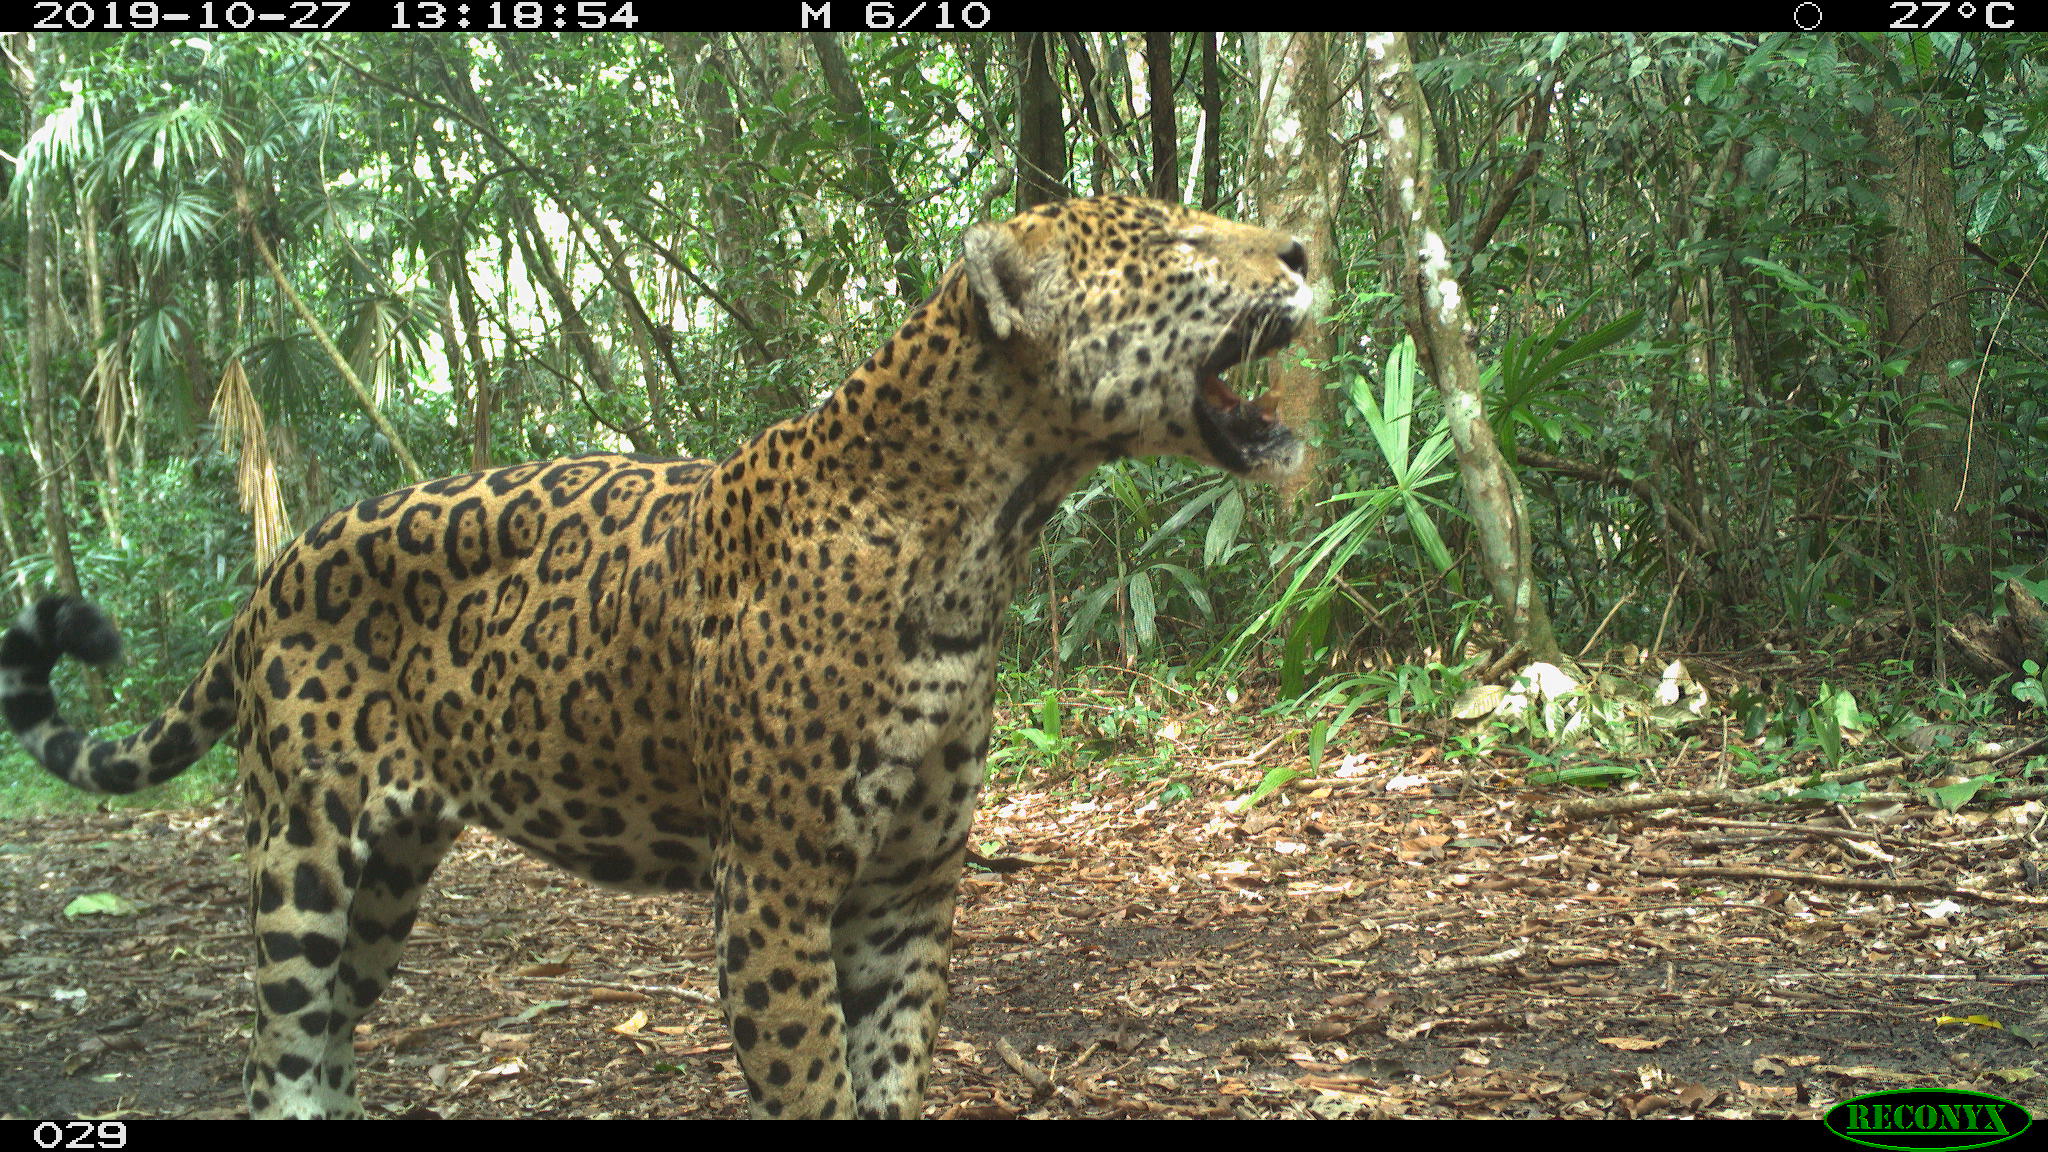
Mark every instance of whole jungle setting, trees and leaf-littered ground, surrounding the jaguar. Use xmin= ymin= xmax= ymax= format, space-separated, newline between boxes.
xmin=0 ymin=33 xmax=2048 ymax=1115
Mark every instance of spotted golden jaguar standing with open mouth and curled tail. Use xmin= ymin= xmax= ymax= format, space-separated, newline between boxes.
xmin=0 ymin=199 xmax=1309 ymax=1117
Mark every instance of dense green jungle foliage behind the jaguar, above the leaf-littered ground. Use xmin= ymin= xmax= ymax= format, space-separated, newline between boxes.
xmin=0 ymin=33 xmax=2048 ymax=815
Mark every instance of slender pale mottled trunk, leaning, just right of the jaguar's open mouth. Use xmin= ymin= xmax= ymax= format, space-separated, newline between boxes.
xmin=1366 ymin=33 xmax=1561 ymax=662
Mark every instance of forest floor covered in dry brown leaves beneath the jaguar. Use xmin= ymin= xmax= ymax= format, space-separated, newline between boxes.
xmin=0 ymin=705 xmax=2048 ymax=1119
